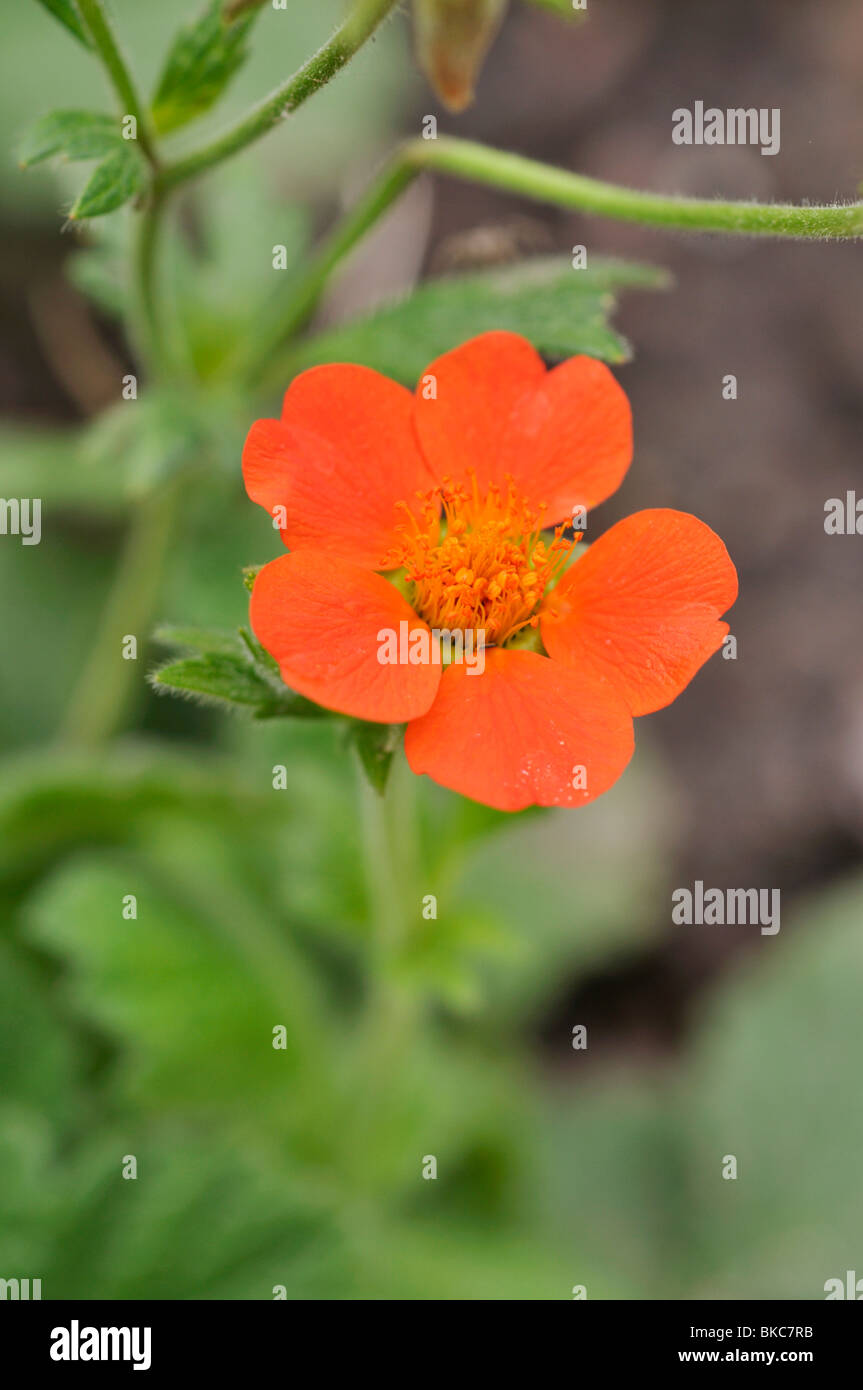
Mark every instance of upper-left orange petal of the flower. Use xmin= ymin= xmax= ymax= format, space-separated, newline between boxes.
xmin=243 ymin=363 xmax=434 ymax=570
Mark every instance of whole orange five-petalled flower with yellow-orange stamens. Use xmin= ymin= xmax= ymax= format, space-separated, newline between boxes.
xmin=243 ymin=332 xmax=737 ymax=810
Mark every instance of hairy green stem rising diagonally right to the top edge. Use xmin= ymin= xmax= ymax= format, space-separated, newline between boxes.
xmin=160 ymin=0 xmax=399 ymax=189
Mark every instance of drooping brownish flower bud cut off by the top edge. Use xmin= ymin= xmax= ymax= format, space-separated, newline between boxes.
xmin=414 ymin=0 xmax=507 ymax=111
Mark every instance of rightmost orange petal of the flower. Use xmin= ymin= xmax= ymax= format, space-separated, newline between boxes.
xmin=541 ymin=507 xmax=737 ymax=714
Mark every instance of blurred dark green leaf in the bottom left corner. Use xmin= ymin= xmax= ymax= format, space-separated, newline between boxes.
xmin=0 ymin=1106 xmax=340 ymax=1300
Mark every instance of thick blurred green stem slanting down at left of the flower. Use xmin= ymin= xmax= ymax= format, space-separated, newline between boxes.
xmin=60 ymin=482 xmax=179 ymax=746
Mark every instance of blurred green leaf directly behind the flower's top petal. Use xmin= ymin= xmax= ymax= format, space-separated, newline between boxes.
xmin=289 ymin=257 xmax=667 ymax=384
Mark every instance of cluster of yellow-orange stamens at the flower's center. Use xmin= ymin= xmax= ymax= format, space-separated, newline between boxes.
xmin=384 ymin=474 xmax=581 ymax=646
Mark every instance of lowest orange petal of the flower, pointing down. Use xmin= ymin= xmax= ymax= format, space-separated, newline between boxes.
xmin=404 ymin=648 xmax=634 ymax=810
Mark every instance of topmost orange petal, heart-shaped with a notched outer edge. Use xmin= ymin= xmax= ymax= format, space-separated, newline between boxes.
xmin=417 ymin=332 xmax=632 ymax=524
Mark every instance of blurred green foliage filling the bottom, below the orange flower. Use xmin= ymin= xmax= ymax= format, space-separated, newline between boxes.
xmin=6 ymin=721 xmax=863 ymax=1298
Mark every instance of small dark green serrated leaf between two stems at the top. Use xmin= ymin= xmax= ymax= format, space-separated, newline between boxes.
xmin=153 ymin=0 xmax=256 ymax=135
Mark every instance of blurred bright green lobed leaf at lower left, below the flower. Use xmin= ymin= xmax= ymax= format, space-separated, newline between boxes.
xmin=25 ymin=845 xmax=327 ymax=1126
